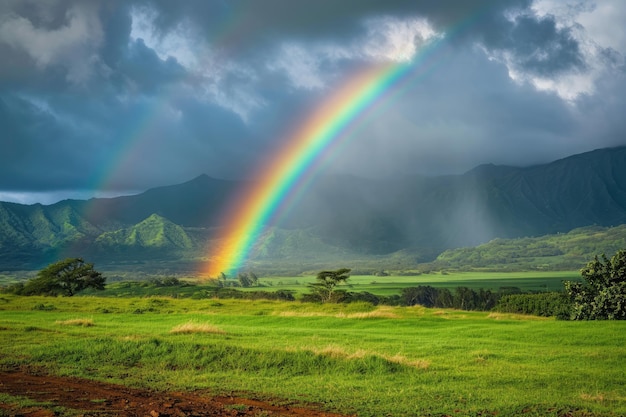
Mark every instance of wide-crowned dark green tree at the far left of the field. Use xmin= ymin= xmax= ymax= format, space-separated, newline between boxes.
xmin=22 ymin=258 xmax=106 ymax=297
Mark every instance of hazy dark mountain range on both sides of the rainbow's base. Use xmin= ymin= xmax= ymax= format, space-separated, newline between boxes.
xmin=0 ymin=147 xmax=626 ymax=270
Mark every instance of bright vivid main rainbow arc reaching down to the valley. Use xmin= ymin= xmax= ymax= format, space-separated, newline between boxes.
xmin=203 ymin=45 xmax=435 ymax=277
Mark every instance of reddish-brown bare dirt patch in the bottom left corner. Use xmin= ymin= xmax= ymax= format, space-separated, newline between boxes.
xmin=0 ymin=370 xmax=352 ymax=417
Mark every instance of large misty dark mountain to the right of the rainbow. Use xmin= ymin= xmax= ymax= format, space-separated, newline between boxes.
xmin=280 ymin=147 xmax=626 ymax=250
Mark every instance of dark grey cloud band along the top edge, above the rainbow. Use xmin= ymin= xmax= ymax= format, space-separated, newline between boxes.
xmin=140 ymin=0 xmax=531 ymax=55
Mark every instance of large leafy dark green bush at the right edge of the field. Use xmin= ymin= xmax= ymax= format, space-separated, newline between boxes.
xmin=564 ymin=250 xmax=626 ymax=320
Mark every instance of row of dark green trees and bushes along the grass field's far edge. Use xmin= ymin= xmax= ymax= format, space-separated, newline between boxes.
xmin=4 ymin=250 xmax=626 ymax=320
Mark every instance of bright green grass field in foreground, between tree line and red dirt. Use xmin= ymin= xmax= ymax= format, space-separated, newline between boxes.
xmin=0 ymin=292 xmax=626 ymax=416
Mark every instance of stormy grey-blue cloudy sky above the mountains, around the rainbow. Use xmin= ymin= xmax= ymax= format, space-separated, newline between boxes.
xmin=0 ymin=0 xmax=626 ymax=204
